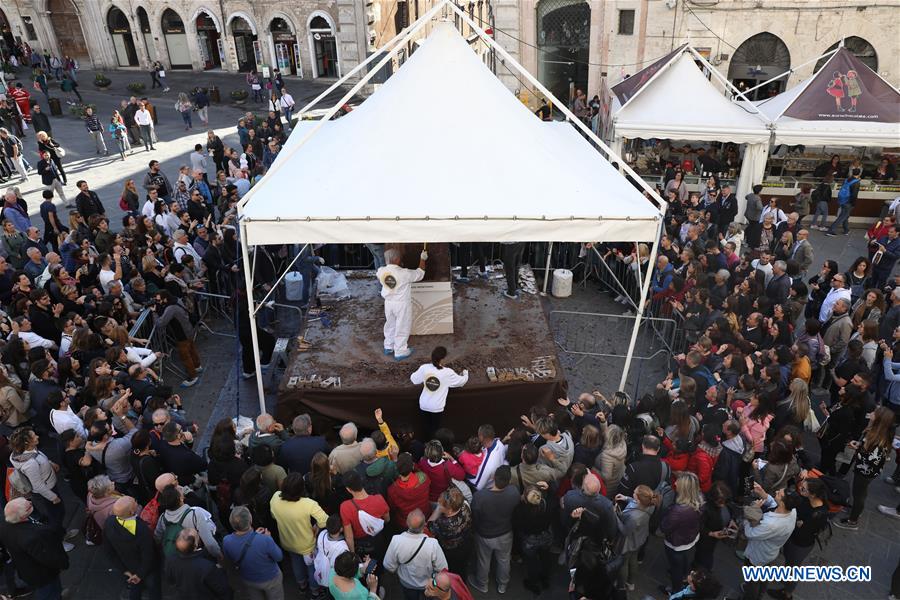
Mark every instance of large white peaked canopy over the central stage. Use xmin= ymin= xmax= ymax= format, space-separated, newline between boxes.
xmin=241 ymin=22 xmax=661 ymax=245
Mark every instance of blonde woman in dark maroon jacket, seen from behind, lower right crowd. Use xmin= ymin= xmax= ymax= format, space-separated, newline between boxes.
xmin=660 ymin=472 xmax=703 ymax=594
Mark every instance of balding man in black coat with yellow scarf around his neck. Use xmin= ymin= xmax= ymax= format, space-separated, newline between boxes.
xmin=103 ymin=496 xmax=162 ymax=600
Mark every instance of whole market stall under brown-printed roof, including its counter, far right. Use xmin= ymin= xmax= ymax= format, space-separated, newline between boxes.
xmin=754 ymin=48 xmax=900 ymax=217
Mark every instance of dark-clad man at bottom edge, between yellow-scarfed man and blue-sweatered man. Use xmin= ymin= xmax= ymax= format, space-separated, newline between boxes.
xmin=166 ymin=527 xmax=233 ymax=600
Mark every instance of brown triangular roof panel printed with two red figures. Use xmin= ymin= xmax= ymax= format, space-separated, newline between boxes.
xmin=784 ymin=48 xmax=900 ymax=123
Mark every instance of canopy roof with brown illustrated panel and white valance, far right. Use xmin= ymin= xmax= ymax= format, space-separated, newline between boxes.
xmin=755 ymin=48 xmax=900 ymax=146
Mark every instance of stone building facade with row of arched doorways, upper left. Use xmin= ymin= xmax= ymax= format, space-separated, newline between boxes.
xmin=0 ymin=0 xmax=369 ymax=78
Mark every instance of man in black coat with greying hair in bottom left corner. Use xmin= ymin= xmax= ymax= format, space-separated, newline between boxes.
xmin=0 ymin=498 xmax=69 ymax=598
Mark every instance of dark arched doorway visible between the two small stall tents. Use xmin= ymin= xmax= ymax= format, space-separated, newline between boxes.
xmin=728 ymin=31 xmax=791 ymax=100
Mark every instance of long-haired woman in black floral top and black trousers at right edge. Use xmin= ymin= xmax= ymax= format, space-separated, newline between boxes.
xmin=832 ymin=408 xmax=896 ymax=531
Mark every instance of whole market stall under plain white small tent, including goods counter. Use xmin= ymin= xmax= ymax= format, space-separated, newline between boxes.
xmin=611 ymin=45 xmax=770 ymax=215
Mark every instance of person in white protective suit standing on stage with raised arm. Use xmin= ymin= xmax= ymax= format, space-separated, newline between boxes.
xmin=375 ymin=248 xmax=428 ymax=360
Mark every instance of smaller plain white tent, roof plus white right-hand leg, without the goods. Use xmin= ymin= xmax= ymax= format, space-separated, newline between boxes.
xmin=612 ymin=45 xmax=771 ymax=215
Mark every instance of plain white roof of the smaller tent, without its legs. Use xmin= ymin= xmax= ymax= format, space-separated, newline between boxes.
xmin=613 ymin=47 xmax=769 ymax=144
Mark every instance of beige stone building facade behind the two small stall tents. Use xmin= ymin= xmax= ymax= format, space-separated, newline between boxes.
xmin=495 ymin=0 xmax=900 ymax=106
